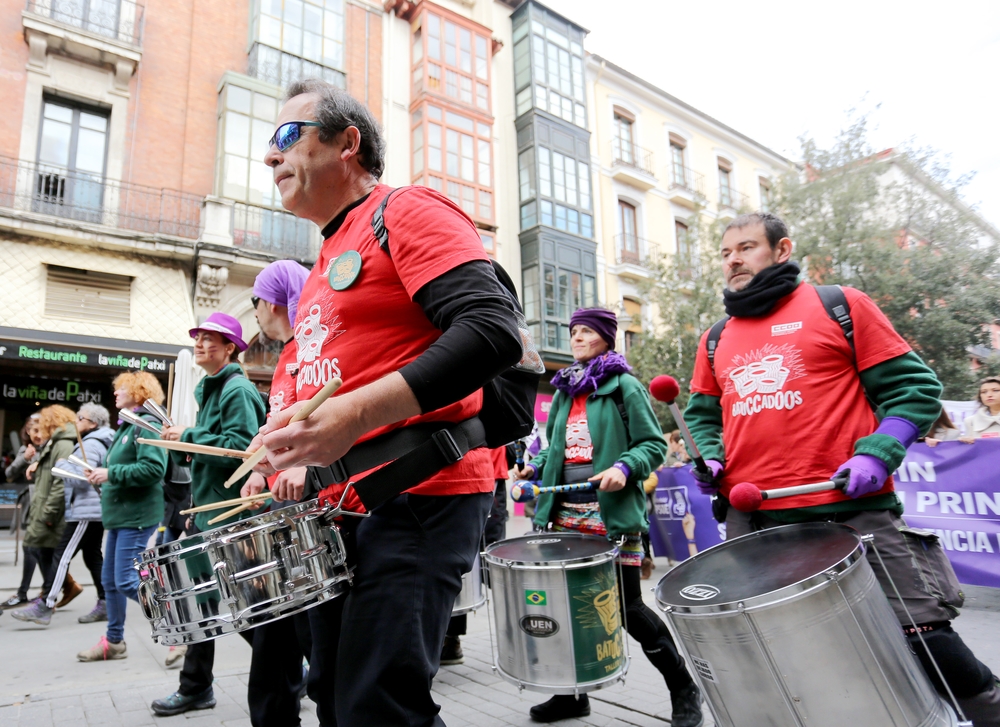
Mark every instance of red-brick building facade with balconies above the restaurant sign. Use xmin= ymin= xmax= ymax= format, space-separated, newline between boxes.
xmin=0 ymin=0 xmax=384 ymax=443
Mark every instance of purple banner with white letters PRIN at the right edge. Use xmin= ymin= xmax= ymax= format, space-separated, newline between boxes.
xmin=893 ymin=439 xmax=1000 ymax=588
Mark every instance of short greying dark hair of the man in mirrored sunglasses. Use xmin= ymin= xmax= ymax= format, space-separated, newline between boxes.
xmin=285 ymin=78 xmax=385 ymax=179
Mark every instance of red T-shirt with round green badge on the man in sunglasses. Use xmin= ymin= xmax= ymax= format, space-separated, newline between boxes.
xmin=295 ymin=185 xmax=495 ymax=495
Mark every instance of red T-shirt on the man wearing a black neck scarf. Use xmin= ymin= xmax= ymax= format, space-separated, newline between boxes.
xmin=691 ymin=284 xmax=910 ymax=510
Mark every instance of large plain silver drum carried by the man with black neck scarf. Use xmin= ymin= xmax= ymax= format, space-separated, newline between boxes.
xmin=656 ymin=523 xmax=957 ymax=727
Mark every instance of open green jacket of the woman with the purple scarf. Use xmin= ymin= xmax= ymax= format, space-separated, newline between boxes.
xmin=531 ymin=374 xmax=667 ymax=538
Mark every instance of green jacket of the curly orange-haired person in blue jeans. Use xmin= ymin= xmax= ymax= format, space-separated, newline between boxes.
xmin=101 ymin=415 xmax=167 ymax=530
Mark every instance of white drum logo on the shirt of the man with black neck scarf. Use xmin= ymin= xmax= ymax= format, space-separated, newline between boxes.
xmin=722 ymin=343 xmax=806 ymax=417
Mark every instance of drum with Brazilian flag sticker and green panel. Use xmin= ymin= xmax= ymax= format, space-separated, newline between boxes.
xmin=485 ymin=532 xmax=629 ymax=694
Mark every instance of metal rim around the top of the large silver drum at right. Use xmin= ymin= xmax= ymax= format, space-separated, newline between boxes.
xmin=654 ymin=523 xmax=865 ymax=616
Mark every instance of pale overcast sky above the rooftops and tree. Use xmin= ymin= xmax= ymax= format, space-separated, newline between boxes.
xmin=542 ymin=0 xmax=1000 ymax=227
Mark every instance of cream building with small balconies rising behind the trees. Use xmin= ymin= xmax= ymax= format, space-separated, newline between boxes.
xmin=587 ymin=54 xmax=792 ymax=343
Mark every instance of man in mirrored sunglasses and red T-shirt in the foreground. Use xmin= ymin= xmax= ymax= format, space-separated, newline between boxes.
xmin=251 ymin=81 xmax=521 ymax=726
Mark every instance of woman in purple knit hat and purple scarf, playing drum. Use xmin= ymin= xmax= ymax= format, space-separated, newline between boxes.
xmin=508 ymin=308 xmax=703 ymax=727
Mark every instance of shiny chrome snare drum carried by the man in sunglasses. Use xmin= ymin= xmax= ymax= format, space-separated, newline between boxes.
xmin=136 ymin=501 xmax=350 ymax=645
